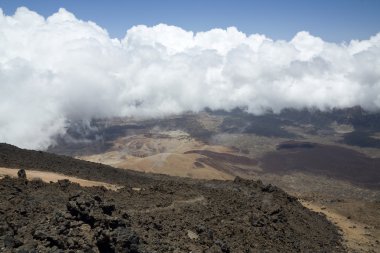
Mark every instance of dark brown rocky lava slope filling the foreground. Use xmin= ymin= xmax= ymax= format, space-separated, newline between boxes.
xmin=0 ymin=145 xmax=345 ymax=252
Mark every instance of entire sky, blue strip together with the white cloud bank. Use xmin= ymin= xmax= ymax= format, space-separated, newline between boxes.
xmin=0 ymin=0 xmax=380 ymax=149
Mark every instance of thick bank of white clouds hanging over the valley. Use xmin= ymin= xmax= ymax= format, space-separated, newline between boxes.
xmin=0 ymin=8 xmax=380 ymax=149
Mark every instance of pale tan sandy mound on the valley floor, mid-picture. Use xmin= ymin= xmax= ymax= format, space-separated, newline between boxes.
xmin=78 ymin=131 xmax=233 ymax=180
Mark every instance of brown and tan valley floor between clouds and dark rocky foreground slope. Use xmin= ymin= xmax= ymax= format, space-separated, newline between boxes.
xmin=44 ymin=107 xmax=380 ymax=252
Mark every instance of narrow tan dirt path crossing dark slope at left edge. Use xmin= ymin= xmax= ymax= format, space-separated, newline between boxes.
xmin=0 ymin=167 xmax=122 ymax=191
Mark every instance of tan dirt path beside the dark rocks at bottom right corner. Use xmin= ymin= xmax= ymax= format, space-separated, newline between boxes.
xmin=300 ymin=200 xmax=380 ymax=252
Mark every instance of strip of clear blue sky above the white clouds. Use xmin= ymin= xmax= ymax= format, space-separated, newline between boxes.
xmin=0 ymin=0 xmax=380 ymax=42
